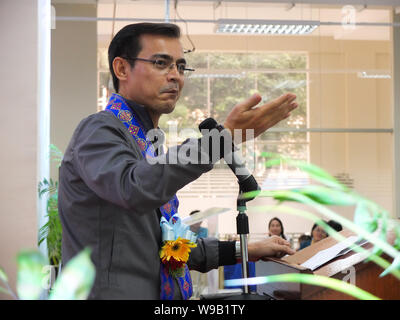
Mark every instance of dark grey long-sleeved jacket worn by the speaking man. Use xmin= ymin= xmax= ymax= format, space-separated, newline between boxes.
xmin=58 ymin=101 xmax=235 ymax=299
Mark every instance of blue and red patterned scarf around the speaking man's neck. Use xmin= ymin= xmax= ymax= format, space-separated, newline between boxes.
xmin=105 ymin=93 xmax=193 ymax=300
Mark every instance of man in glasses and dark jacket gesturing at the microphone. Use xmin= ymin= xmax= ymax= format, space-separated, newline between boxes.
xmin=58 ymin=23 xmax=297 ymax=299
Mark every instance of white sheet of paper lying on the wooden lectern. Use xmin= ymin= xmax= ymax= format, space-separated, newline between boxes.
xmin=302 ymin=236 xmax=366 ymax=270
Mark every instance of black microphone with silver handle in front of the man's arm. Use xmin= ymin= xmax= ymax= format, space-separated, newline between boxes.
xmin=199 ymin=118 xmax=260 ymax=201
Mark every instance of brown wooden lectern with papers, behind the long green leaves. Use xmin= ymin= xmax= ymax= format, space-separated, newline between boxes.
xmin=256 ymin=230 xmax=400 ymax=300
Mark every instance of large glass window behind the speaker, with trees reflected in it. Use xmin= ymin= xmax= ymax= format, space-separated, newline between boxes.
xmin=99 ymin=2 xmax=393 ymax=233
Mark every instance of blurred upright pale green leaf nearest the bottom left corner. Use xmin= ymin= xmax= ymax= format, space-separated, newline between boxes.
xmin=17 ymin=251 xmax=47 ymax=300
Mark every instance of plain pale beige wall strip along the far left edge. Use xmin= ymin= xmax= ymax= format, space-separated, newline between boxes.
xmin=0 ymin=0 xmax=43 ymax=298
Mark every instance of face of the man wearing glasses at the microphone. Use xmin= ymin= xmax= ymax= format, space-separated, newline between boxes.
xmin=127 ymin=34 xmax=185 ymax=115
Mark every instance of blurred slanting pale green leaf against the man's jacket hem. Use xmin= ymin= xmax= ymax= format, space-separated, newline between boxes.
xmin=49 ymin=248 xmax=96 ymax=300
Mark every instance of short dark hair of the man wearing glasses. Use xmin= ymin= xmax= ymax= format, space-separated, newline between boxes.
xmin=108 ymin=22 xmax=181 ymax=92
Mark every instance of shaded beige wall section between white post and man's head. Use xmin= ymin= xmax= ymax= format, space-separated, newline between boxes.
xmin=50 ymin=4 xmax=97 ymax=177
